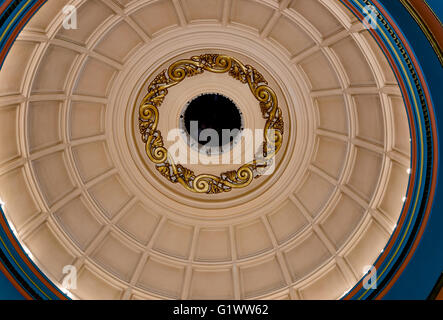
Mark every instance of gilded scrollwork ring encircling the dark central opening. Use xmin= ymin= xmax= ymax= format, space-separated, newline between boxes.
xmin=139 ymin=54 xmax=284 ymax=194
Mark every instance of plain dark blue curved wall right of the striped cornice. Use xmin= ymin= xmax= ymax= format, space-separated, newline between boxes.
xmin=382 ymin=0 xmax=443 ymax=299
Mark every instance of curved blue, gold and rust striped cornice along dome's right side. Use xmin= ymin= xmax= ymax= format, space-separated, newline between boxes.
xmin=342 ymin=0 xmax=438 ymax=299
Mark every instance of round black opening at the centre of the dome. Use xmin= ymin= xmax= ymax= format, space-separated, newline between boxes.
xmin=186 ymin=93 xmax=243 ymax=146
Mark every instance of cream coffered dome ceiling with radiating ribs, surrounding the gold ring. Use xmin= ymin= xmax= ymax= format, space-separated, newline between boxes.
xmin=0 ymin=0 xmax=411 ymax=299
